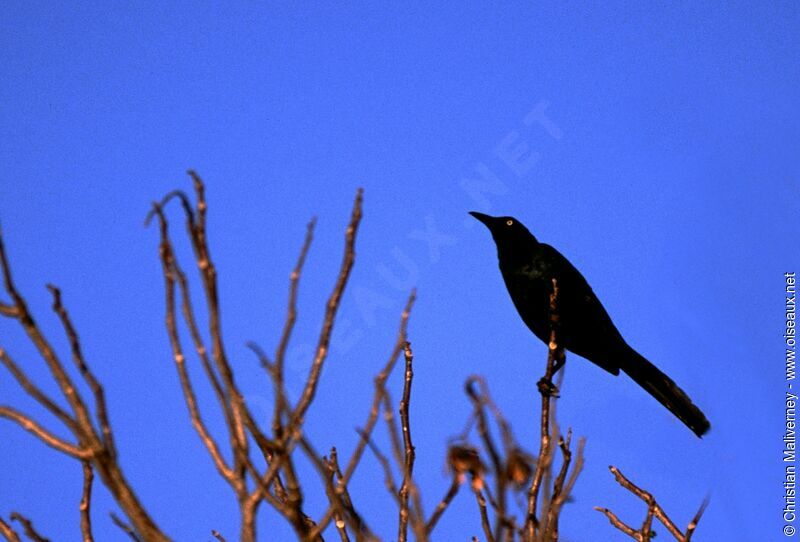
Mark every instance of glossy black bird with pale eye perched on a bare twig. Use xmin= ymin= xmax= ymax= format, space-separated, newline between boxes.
xmin=470 ymin=212 xmax=711 ymax=437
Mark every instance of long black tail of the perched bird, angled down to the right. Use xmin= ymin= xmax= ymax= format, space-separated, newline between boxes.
xmin=620 ymin=348 xmax=711 ymax=437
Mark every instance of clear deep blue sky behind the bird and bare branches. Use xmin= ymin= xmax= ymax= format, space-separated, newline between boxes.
xmin=0 ymin=2 xmax=800 ymax=542
